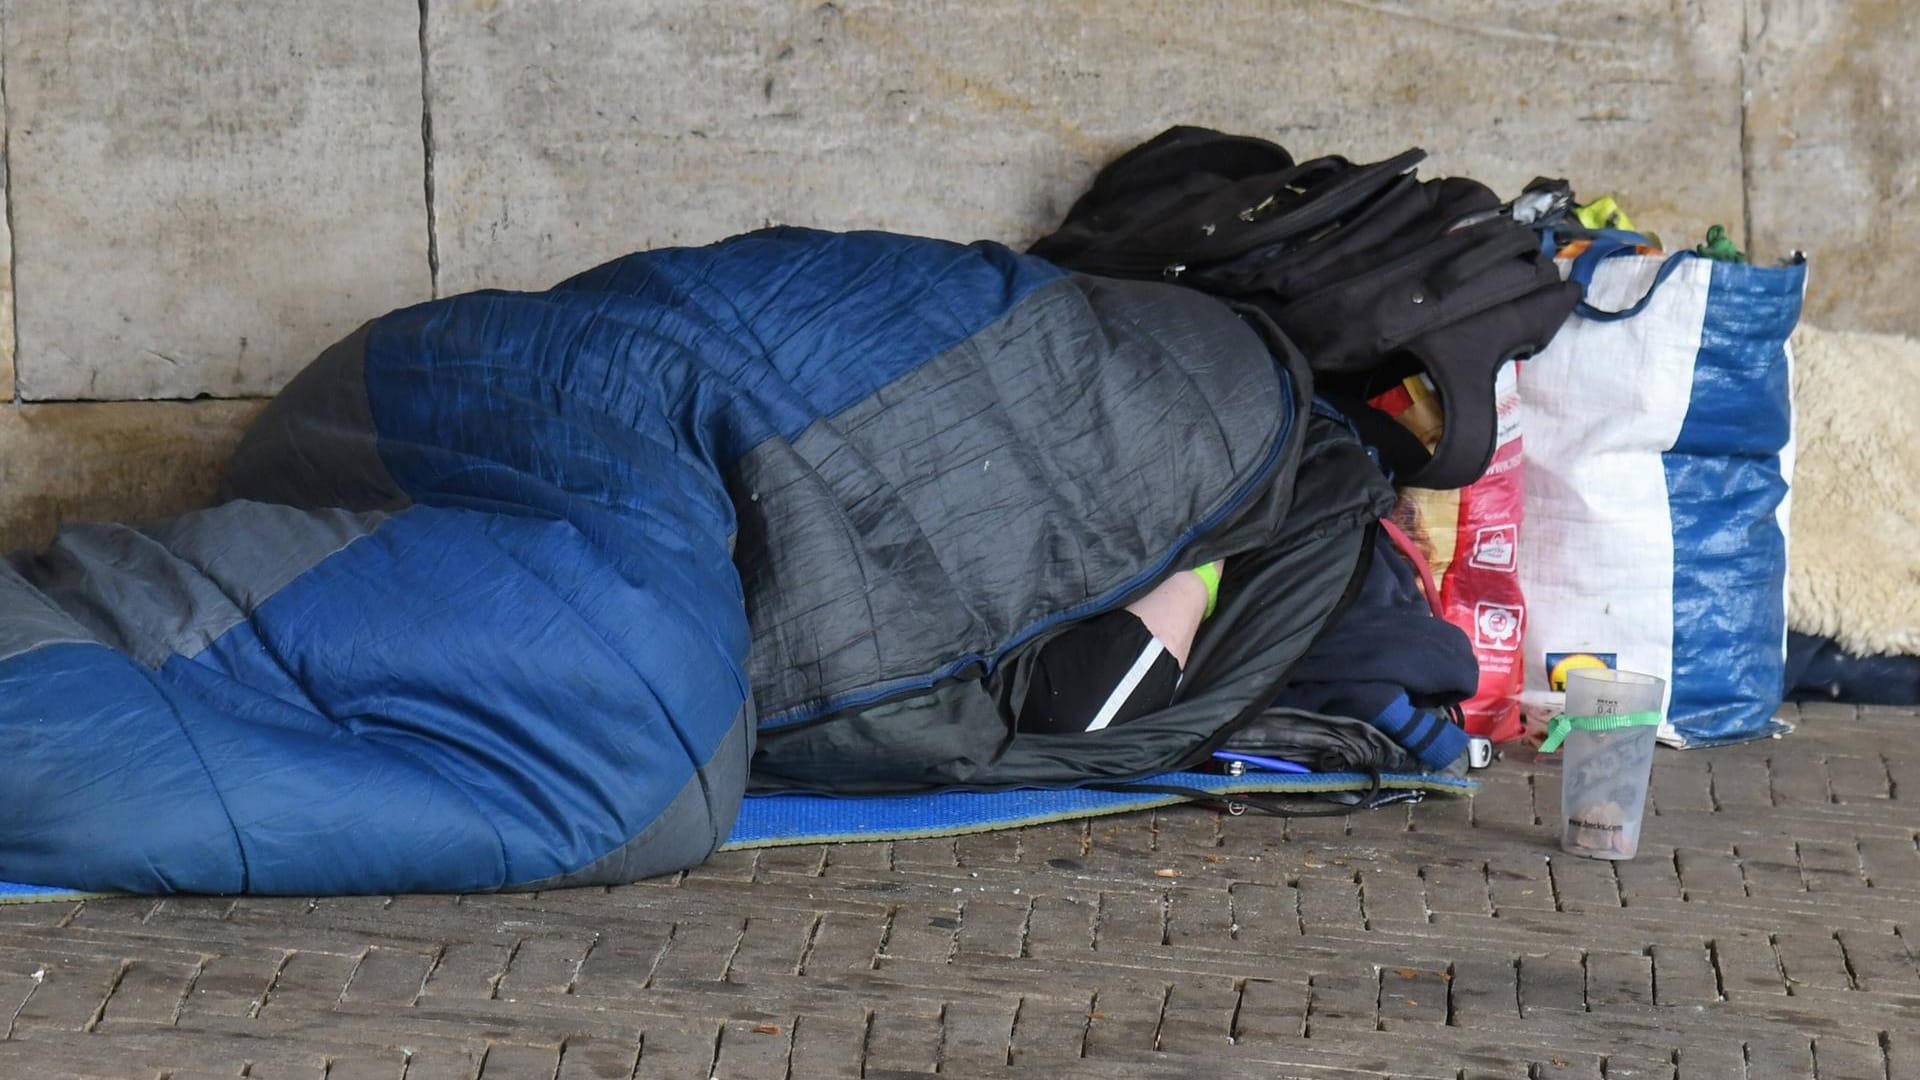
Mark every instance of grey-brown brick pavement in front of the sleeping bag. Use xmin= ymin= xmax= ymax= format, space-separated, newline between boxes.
xmin=0 ymin=705 xmax=1920 ymax=1080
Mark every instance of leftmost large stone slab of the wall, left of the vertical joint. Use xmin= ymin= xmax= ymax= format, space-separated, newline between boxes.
xmin=6 ymin=0 xmax=430 ymax=400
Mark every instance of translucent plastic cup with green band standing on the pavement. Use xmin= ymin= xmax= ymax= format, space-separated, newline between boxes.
xmin=1546 ymin=669 xmax=1667 ymax=859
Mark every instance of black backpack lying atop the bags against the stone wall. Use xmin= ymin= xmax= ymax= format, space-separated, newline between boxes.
xmin=1031 ymin=127 xmax=1580 ymax=488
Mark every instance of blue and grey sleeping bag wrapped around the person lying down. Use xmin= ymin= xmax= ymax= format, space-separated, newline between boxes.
xmin=0 ymin=229 xmax=1392 ymax=894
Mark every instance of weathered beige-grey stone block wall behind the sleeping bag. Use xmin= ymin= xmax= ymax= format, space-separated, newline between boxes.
xmin=0 ymin=0 xmax=1920 ymax=548
